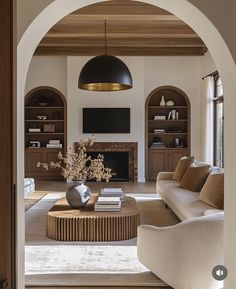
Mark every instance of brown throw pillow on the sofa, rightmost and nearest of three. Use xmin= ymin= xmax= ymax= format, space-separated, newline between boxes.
xmin=199 ymin=172 xmax=224 ymax=210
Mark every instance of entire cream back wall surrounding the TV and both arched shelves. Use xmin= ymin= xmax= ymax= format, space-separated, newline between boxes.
xmin=26 ymin=56 xmax=202 ymax=182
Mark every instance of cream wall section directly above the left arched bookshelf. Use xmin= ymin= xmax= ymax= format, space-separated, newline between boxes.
xmin=25 ymin=56 xmax=67 ymax=97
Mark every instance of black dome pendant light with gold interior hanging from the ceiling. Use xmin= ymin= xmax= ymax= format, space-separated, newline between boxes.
xmin=78 ymin=20 xmax=133 ymax=91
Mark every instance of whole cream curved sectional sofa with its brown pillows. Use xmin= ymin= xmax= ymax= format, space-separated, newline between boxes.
xmin=137 ymin=160 xmax=224 ymax=289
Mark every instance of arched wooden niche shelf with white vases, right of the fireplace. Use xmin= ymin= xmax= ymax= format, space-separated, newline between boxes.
xmin=145 ymin=86 xmax=191 ymax=180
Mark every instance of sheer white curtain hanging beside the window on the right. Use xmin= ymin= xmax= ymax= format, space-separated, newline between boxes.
xmin=202 ymin=76 xmax=214 ymax=165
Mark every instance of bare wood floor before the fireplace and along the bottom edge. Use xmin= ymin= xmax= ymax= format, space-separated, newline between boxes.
xmin=26 ymin=181 xmax=171 ymax=289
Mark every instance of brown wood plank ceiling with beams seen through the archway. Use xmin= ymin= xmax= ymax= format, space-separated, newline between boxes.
xmin=35 ymin=0 xmax=207 ymax=56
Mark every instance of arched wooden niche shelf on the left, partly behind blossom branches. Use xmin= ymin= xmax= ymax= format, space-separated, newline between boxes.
xmin=25 ymin=86 xmax=67 ymax=180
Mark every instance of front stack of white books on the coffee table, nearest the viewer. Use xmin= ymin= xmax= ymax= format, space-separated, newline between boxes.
xmin=94 ymin=197 xmax=121 ymax=212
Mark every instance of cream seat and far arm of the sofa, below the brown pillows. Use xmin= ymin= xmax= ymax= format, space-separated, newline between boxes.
xmin=156 ymin=172 xmax=223 ymax=221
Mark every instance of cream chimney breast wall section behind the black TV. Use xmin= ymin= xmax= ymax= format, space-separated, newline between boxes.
xmin=67 ymin=57 xmax=144 ymax=181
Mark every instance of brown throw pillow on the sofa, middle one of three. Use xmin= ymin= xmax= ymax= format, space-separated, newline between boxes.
xmin=180 ymin=162 xmax=211 ymax=192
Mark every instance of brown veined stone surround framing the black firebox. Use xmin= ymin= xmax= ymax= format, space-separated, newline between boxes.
xmin=74 ymin=142 xmax=138 ymax=182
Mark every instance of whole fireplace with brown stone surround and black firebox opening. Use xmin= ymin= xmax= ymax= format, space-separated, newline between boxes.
xmin=74 ymin=142 xmax=137 ymax=182
